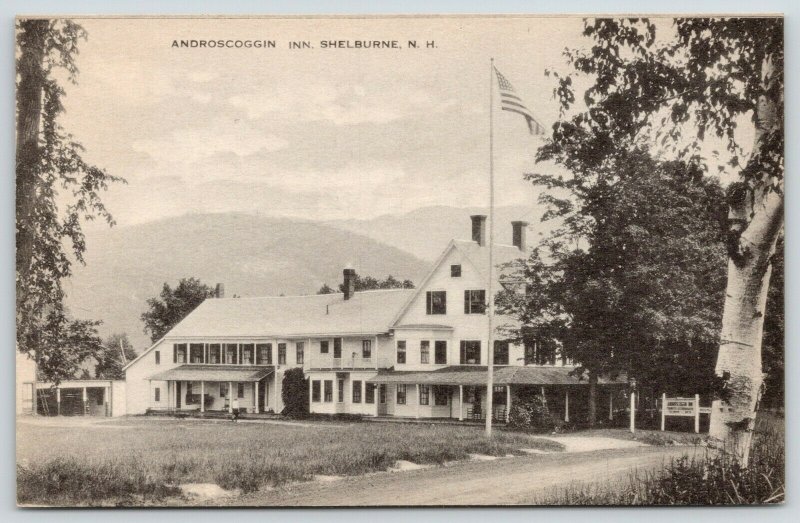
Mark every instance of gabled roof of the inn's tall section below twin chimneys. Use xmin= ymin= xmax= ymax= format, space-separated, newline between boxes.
xmin=392 ymin=240 xmax=526 ymax=326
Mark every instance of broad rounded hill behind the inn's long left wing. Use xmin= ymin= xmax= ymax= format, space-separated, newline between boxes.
xmin=66 ymin=214 xmax=432 ymax=351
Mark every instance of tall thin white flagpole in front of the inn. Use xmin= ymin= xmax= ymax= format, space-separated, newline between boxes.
xmin=486 ymin=58 xmax=495 ymax=437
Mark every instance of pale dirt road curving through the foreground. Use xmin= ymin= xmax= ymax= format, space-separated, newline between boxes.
xmin=222 ymin=447 xmax=695 ymax=506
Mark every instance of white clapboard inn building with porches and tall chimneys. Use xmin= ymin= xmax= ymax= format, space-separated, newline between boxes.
xmin=125 ymin=215 xmax=626 ymax=421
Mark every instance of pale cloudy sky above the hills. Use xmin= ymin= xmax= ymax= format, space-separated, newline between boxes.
xmin=53 ymin=18 xmax=582 ymax=225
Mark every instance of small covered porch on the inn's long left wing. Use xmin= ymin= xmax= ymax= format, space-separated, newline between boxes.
xmin=148 ymin=364 xmax=280 ymax=414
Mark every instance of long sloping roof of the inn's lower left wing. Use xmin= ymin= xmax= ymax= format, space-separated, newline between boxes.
xmin=164 ymin=289 xmax=414 ymax=339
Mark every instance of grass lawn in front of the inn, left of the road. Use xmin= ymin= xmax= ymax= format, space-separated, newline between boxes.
xmin=17 ymin=418 xmax=561 ymax=505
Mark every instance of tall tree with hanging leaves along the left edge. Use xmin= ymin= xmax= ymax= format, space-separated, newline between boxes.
xmin=16 ymin=19 xmax=121 ymax=382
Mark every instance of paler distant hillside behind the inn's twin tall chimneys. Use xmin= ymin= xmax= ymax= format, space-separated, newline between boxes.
xmin=327 ymin=205 xmax=551 ymax=260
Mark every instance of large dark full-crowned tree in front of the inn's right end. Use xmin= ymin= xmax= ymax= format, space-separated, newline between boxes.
xmin=498 ymin=150 xmax=725 ymax=424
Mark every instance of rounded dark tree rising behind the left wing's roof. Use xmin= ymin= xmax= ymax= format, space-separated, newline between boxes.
xmin=141 ymin=278 xmax=215 ymax=343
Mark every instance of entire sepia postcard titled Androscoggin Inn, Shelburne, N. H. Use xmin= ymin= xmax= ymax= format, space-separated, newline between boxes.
xmin=16 ymin=14 xmax=785 ymax=507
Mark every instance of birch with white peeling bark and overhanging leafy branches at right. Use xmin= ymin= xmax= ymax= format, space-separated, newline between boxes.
xmin=538 ymin=17 xmax=784 ymax=464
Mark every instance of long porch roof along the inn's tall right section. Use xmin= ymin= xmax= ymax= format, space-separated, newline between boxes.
xmin=367 ymin=365 xmax=627 ymax=385
